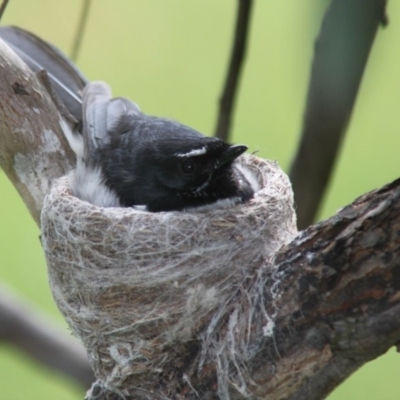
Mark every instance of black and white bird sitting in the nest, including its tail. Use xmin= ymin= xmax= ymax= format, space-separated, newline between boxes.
xmin=0 ymin=27 xmax=258 ymax=212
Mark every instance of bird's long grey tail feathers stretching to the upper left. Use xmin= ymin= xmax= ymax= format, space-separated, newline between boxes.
xmin=0 ymin=26 xmax=88 ymax=121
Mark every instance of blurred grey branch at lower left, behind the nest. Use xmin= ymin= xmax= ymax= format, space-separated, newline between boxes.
xmin=0 ymin=285 xmax=94 ymax=388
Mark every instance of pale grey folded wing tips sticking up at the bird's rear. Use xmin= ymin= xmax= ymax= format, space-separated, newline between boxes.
xmin=82 ymin=82 xmax=141 ymax=160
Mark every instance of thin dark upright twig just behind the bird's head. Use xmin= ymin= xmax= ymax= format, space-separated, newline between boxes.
xmin=215 ymin=0 xmax=253 ymax=140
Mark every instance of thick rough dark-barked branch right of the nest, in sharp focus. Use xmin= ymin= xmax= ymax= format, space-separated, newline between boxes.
xmin=252 ymin=180 xmax=400 ymax=400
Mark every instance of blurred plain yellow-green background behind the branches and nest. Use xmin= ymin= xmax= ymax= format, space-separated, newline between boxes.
xmin=0 ymin=0 xmax=400 ymax=400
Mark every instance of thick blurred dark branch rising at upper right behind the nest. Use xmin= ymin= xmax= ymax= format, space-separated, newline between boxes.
xmin=290 ymin=0 xmax=386 ymax=229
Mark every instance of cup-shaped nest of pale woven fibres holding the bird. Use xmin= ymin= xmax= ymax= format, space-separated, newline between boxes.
xmin=41 ymin=156 xmax=296 ymax=399
